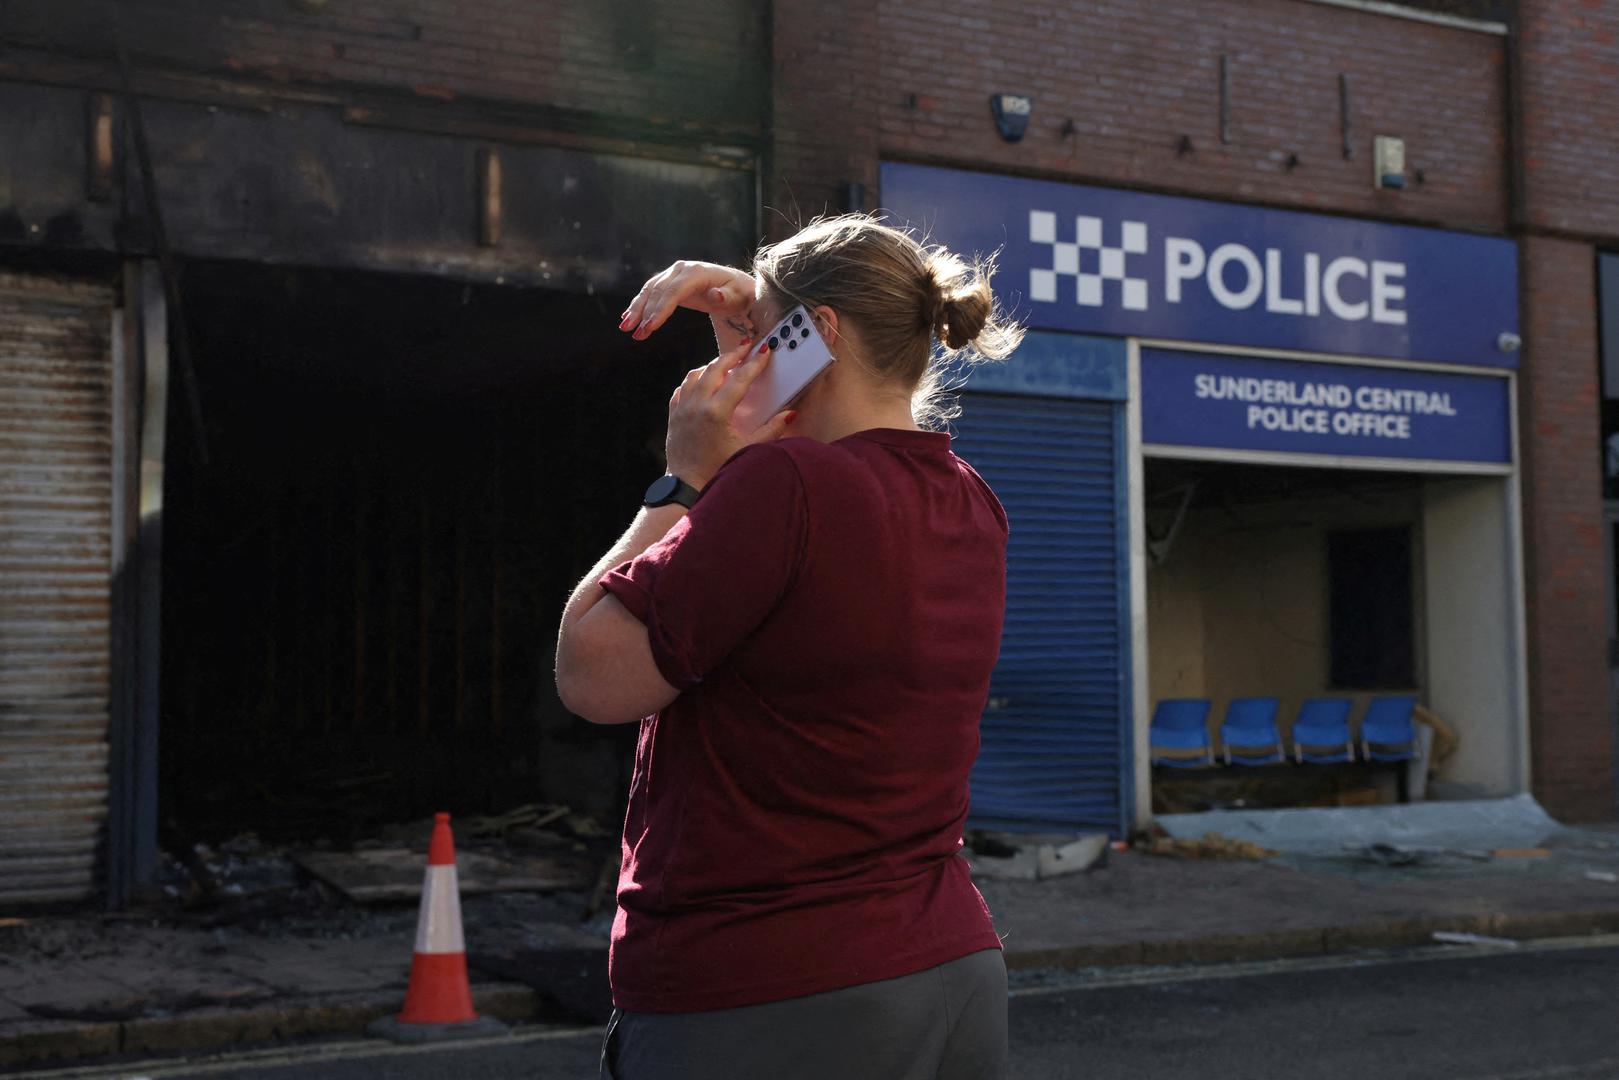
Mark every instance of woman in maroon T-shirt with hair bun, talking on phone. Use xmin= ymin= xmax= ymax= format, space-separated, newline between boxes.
xmin=557 ymin=215 xmax=1020 ymax=1080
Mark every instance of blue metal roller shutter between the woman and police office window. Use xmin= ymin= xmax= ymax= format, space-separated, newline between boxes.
xmin=955 ymin=393 xmax=1130 ymax=836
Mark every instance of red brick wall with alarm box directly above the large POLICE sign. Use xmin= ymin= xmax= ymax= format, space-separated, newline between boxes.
xmin=861 ymin=0 xmax=1506 ymax=230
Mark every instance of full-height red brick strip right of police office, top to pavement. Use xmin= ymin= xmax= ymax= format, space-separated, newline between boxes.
xmin=1515 ymin=0 xmax=1619 ymax=818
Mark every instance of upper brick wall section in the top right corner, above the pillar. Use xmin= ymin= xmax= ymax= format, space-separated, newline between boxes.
xmin=1519 ymin=0 xmax=1619 ymax=240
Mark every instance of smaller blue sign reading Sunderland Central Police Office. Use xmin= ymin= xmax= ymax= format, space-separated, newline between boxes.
xmin=1141 ymin=348 xmax=1512 ymax=465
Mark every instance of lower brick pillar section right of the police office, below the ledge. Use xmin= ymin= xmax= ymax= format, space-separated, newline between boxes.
xmin=1519 ymin=236 xmax=1613 ymax=821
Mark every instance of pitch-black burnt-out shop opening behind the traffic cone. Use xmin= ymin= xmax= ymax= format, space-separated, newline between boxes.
xmin=162 ymin=264 xmax=712 ymax=840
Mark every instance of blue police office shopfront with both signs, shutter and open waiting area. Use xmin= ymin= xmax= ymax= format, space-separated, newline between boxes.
xmin=882 ymin=164 xmax=1528 ymax=834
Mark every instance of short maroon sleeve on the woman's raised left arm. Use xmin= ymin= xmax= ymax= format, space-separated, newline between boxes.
xmin=601 ymin=444 xmax=808 ymax=690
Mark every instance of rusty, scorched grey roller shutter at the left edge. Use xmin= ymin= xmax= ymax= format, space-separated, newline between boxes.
xmin=0 ymin=274 xmax=113 ymax=905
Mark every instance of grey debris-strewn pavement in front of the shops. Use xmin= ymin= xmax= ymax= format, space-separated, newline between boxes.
xmin=9 ymin=829 xmax=1619 ymax=1067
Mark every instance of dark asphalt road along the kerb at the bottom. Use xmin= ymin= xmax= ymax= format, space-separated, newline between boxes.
xmin=19 ymin=939 xmax=1619 ymax=1080
